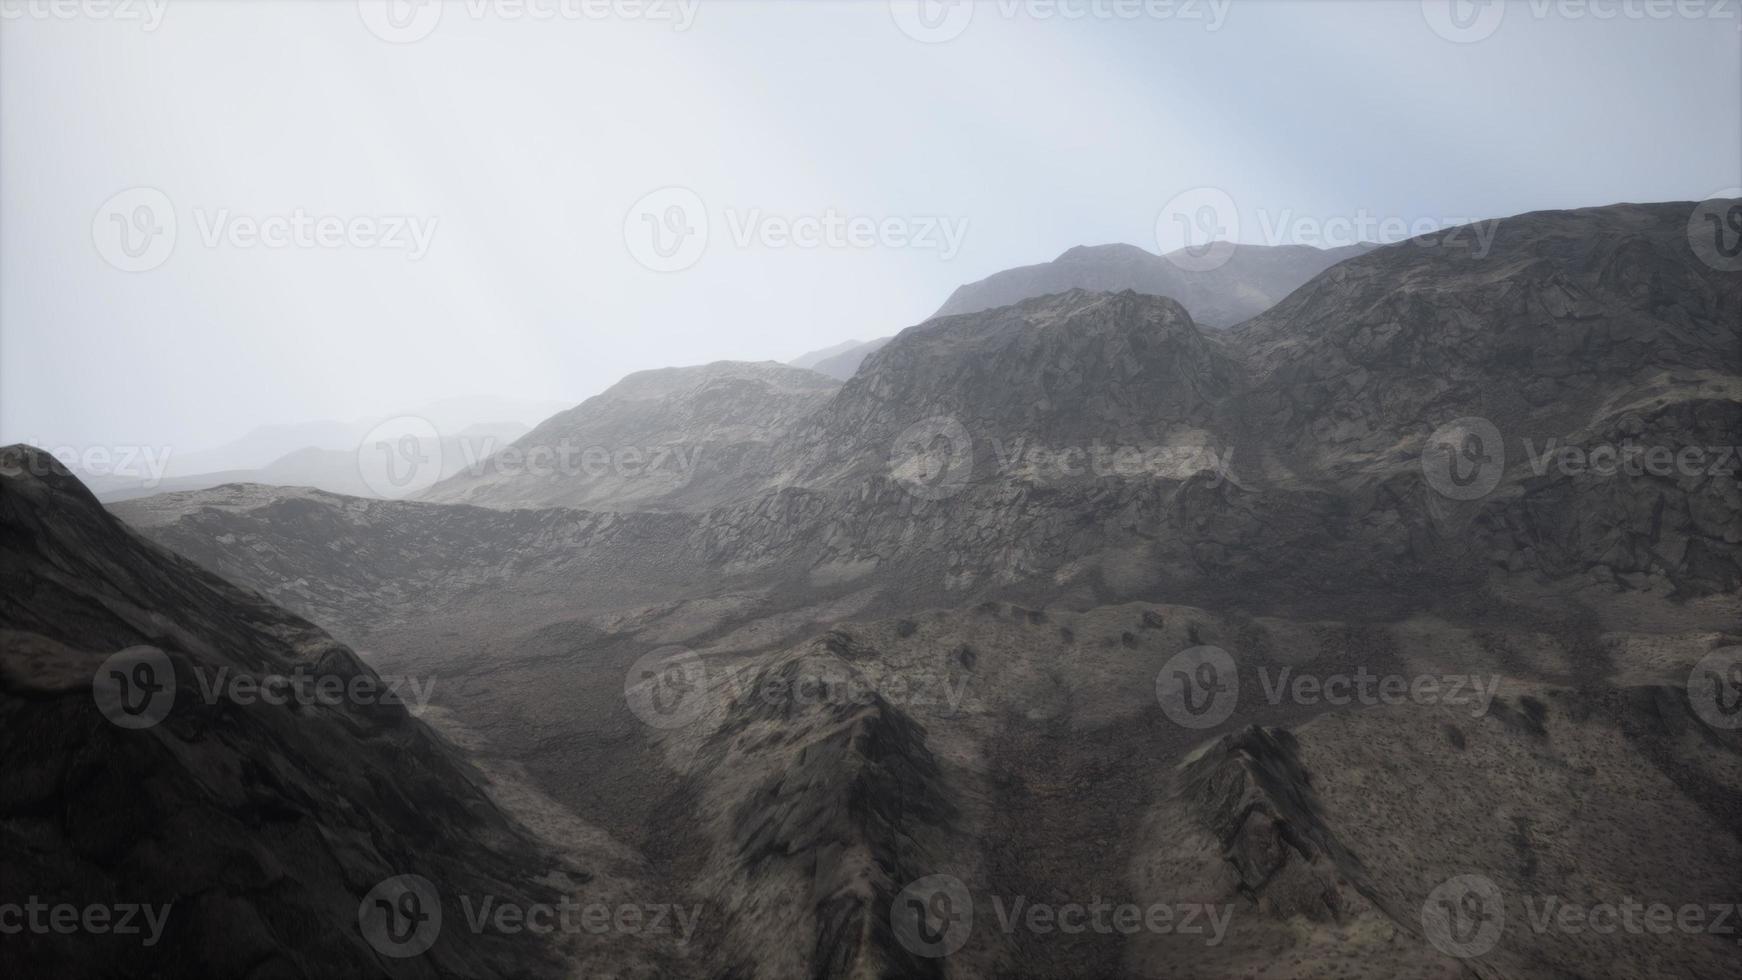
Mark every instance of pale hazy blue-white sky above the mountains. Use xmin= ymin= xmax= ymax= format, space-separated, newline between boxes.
xmin=0 ymin=0 xmax=1742 ymax=453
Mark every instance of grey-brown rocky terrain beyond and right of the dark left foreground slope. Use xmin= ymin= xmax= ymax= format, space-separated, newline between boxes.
xmin=20 ymin=204 xmax=1742 ymax=978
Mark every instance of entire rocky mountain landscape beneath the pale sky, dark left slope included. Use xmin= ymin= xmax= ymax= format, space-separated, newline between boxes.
xmin=13 ymin=189 xmax=1742 ymax=978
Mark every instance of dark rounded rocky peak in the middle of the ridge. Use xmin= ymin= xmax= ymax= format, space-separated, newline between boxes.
xmin=777 ymin=291 xmax=1235 ymax=486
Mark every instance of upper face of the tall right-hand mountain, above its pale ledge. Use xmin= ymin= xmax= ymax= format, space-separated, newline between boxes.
xmin=1230 ymin=204 xmax=1742 ymax=472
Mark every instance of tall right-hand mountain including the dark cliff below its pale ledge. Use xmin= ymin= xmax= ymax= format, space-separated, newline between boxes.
xmin=1230 ymin=204 xmax=1742 ymax=594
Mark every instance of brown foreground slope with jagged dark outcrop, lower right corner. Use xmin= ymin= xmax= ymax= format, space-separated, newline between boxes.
xmin=1127 ymin=684 xmax=1742 ymax=978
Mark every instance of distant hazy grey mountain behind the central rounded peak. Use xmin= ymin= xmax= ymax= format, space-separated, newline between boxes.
xmin=934 ymin=244 xmax=1374 ymax=327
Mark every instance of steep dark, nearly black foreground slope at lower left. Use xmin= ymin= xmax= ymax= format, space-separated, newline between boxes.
xmin=0 ymin=446 xmax=665 ymax=977
